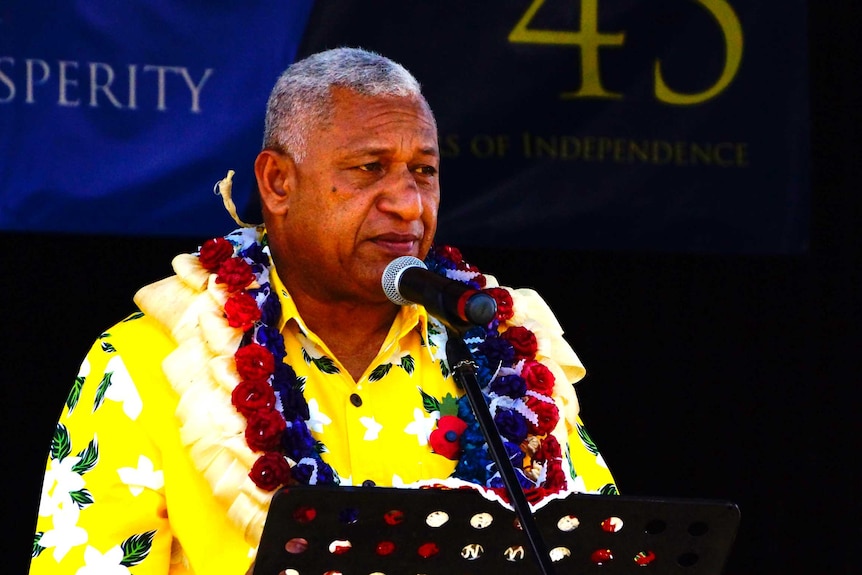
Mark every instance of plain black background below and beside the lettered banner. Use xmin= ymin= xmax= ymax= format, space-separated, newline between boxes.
xmin=0 ymin=2 xmax=862 ymax=574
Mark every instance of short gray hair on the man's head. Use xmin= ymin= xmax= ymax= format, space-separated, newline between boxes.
xmin=263 ymin=48 xmax=425 ymax=162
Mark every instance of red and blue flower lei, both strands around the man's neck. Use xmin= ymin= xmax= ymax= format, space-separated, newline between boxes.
xmin=195 ymin=228 xmax=567 ymax=501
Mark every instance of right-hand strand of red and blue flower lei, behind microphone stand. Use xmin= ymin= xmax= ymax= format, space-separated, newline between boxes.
xmin=425 ymin=246 xmax=568 ymax=502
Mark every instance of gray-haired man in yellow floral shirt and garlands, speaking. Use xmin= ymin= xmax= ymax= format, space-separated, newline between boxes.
xmin=31 ymin=49 xmax=614 ymax=575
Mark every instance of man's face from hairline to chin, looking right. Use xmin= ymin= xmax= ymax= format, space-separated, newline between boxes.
xmin=270 ymin=88 xmax=440 ymax=303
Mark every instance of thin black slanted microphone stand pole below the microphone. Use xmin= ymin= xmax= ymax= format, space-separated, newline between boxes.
xmin=446 ymin=327 xmax=554 ymax=575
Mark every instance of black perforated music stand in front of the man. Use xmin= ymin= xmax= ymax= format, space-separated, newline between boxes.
xmin=254 ymin=486 xmax=739 ymax=575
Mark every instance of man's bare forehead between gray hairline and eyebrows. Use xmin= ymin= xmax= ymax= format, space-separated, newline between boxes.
xmin=315 ymin=88 xmax=437 ymax=154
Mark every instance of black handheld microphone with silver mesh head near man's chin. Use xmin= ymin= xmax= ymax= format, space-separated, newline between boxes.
xmin=381 ymin=256 xmax=497 ymax=329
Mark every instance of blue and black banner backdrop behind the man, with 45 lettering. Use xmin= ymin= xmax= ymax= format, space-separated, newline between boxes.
xmin=0 ymin=0 xmax=809 ymax=253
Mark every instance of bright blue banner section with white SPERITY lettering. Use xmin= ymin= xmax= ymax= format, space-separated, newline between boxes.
xmin=0 ymin=0 xmax=312 ymax=236
